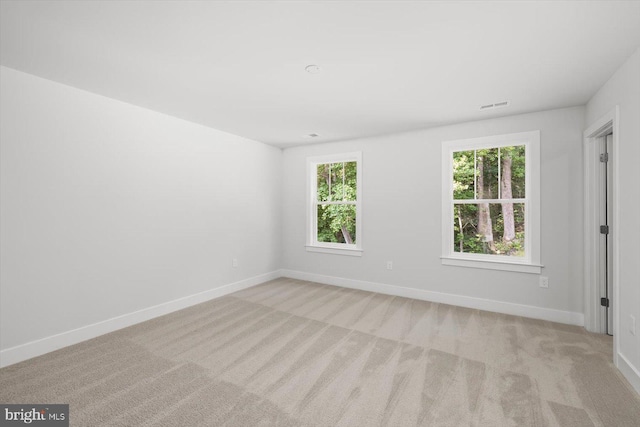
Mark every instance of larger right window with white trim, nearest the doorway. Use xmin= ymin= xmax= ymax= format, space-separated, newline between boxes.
xmin=442 ymin=131 xmax=541 ymax=273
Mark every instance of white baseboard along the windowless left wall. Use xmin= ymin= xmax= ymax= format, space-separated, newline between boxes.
xmin=0 ymin=270 xmax=282 ymax=368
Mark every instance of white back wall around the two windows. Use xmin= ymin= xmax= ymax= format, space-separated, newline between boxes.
xmin=283 ymin=107 xmax=584 ymax=324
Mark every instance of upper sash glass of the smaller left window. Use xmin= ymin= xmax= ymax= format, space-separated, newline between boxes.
xmin=316 ymin=162 xmax=357 ymax=202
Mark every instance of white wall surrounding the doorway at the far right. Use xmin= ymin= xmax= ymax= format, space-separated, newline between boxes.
xmin=586 ymin=49 xmax=640 ymax=392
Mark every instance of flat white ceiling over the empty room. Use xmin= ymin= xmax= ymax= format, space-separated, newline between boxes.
xmin=0 ymin=1 xmax=640 ymax=147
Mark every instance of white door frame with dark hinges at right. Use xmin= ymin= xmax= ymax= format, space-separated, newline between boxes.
xmin=583 ymin=106 xmax=620 ymax=366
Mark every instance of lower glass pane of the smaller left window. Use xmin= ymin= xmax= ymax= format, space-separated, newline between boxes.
xmin=318 ymin=205 xmax=356 ymax=244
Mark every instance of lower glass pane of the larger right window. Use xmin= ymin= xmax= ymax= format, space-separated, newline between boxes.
xmin=453 ymin=203 xmax=525 ymax=257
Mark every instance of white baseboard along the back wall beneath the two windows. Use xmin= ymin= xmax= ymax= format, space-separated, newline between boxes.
xmin=281 ymin=269 xmax=584 ymax=326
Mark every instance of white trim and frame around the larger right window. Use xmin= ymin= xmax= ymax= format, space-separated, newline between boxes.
xmin=441 ymin=131 xmax=543 ymax=274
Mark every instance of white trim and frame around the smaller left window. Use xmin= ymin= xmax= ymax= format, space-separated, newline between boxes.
xmin=306 ymin=151 xmax=363 ymax=256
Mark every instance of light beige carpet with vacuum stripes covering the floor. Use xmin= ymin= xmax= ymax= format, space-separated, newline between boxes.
xmin=0 ymin=279 xmax=640 ymax=427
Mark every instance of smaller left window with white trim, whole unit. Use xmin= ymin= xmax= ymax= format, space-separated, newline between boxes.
xmin=307 ymin=152 xmax=362 ymax=256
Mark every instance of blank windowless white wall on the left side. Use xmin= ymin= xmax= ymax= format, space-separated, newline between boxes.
xmin=0 ymin=67 xmax=282 ymax=364
